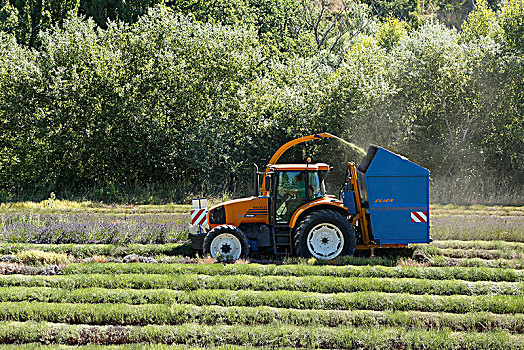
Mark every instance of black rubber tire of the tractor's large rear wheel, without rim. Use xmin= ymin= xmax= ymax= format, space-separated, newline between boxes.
xmin=294 ymin=209 xmax=357 ymax=259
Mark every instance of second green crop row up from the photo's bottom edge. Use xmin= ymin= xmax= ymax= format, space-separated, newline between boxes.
xmin=0 ymin=295 xmax=524 ymax=333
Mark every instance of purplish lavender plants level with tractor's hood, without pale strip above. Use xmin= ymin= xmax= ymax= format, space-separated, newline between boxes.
xmin=0 ymin=213 xmax=524 ymax=244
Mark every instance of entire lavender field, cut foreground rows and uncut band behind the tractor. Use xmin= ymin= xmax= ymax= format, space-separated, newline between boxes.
xmin=0 ymin=201 xmax=524 ymax=350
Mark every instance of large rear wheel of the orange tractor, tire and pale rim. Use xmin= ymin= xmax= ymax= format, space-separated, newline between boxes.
xmin=295 ymin=209 xmax=357 ymax=260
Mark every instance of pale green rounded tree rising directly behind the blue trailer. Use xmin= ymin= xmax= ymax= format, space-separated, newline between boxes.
xmin=372 ymin=25 xmax=501 ymax=178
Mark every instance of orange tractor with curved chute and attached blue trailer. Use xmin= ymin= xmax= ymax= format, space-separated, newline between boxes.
xmin=189 ymin=133 xmax=430 ymax=260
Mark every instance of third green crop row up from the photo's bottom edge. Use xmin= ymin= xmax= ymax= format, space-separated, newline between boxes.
xmin=0 ymin=287 xmax=524 ymax=314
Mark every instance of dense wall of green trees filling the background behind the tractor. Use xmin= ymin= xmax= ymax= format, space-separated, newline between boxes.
xmin=0 ymin=0 xmax=524 ymax=202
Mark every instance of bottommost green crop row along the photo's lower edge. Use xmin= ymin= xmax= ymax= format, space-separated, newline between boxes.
xmin=0 ymin=322 xmax=524 ymax=350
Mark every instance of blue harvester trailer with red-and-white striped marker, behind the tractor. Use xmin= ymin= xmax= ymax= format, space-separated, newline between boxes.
xmin=341 ymin=145 xmax=430 ymax=249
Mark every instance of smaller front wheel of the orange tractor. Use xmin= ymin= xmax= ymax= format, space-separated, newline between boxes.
xmin=204 ymin=225 xmax=249 ymax=260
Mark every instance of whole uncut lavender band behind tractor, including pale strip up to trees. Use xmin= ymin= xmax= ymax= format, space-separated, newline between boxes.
xmin=0 ymin=201 xmax=524 ymax=244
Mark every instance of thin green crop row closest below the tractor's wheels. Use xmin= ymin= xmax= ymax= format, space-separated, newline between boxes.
xmin=63 ymin=263 xmax=524 ymax=282
